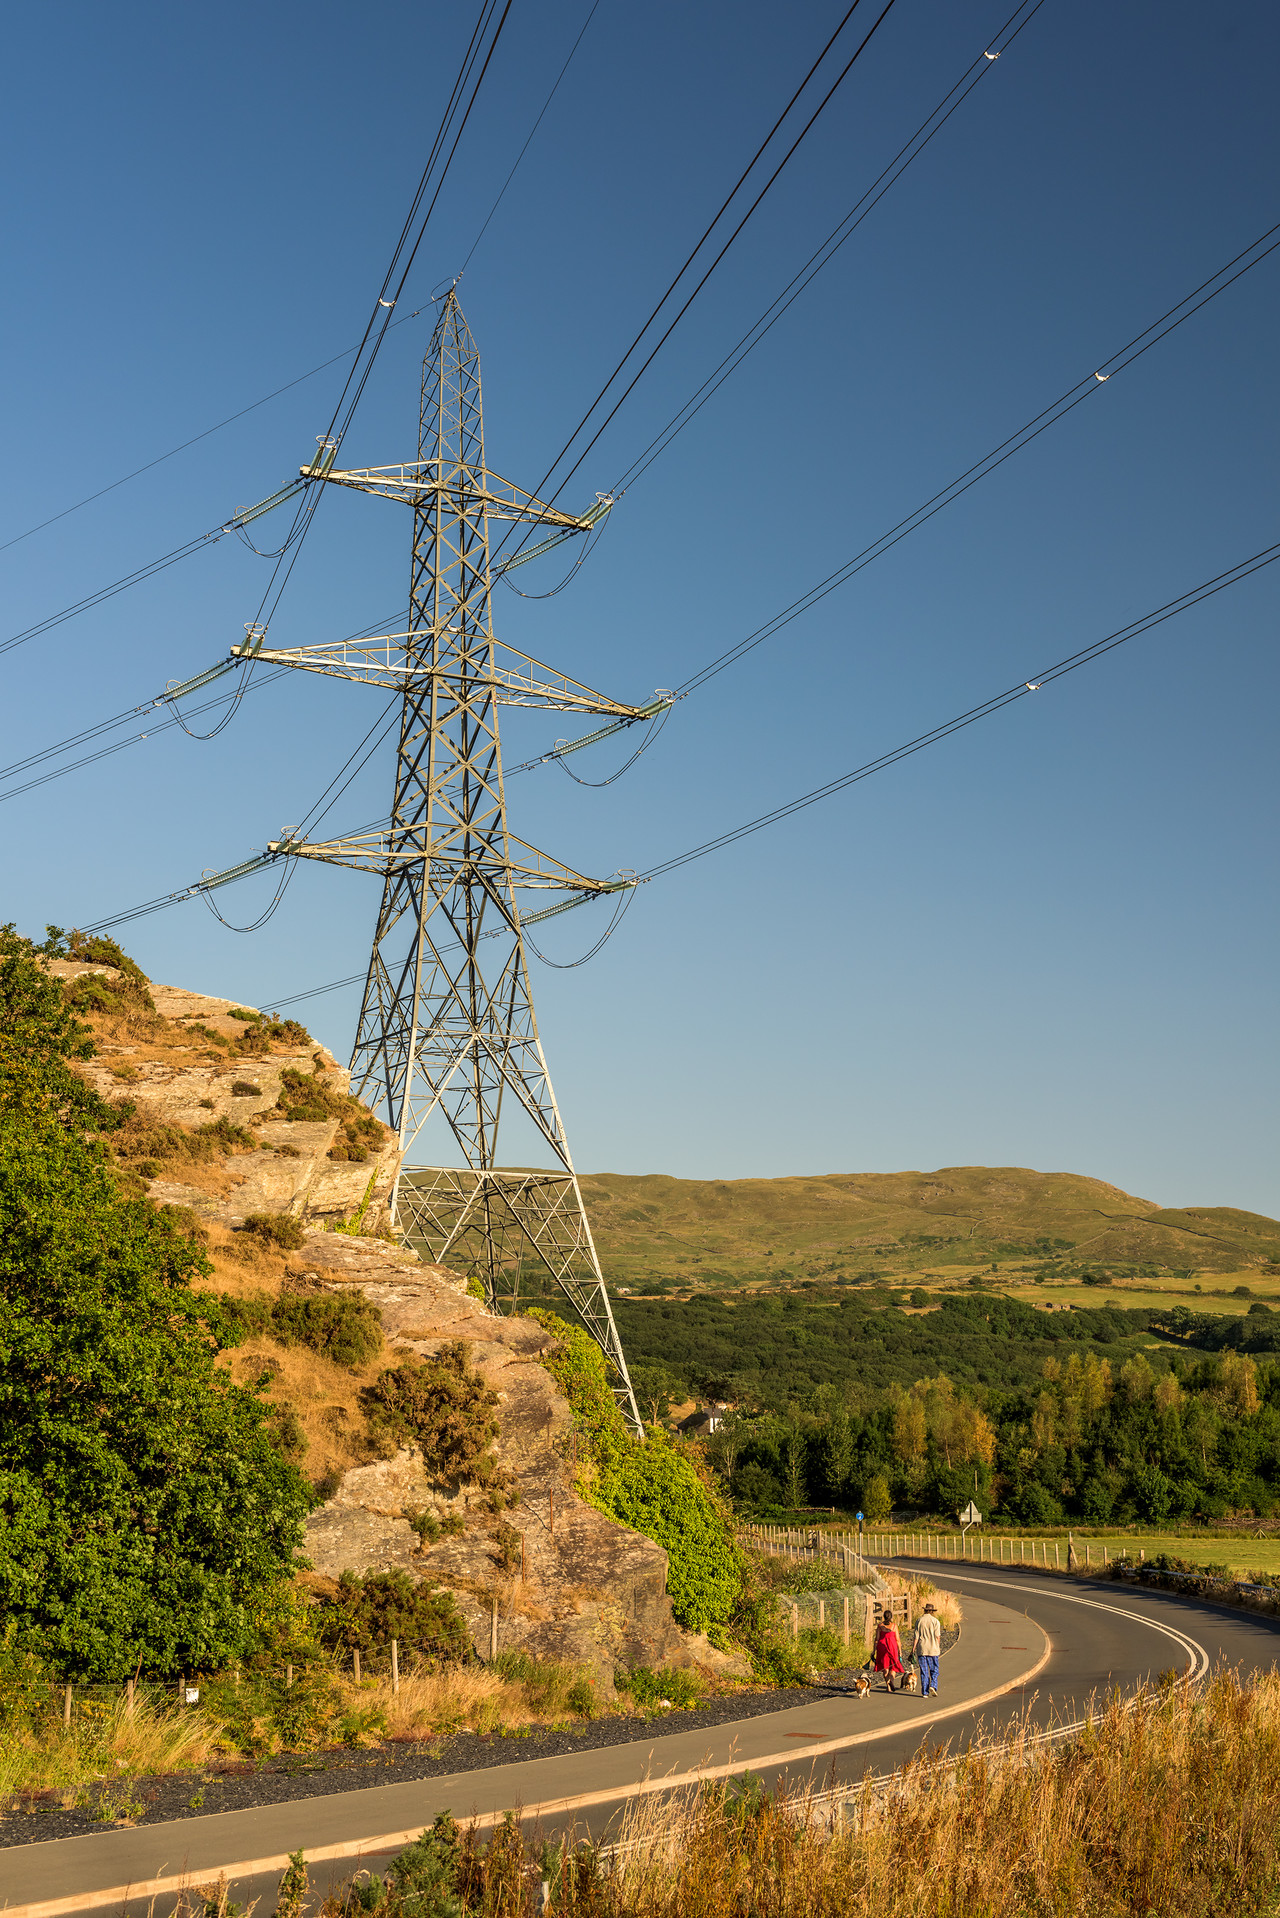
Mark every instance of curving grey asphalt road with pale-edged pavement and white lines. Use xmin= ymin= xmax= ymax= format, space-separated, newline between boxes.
xmin=12 ymin=1559 xmax=1280 ymax=1918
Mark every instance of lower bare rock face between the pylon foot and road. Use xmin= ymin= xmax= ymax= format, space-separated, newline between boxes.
xmin=297 ymin=1233 xmax=741 ymax=1690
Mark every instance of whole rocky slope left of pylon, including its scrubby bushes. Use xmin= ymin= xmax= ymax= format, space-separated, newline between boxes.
xmin=40 ymin=942 xmax=741 ymax=1692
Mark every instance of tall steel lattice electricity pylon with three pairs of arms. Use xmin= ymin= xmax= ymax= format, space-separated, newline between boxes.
xmin=243 ymin=293 xmax=656 ymax=1431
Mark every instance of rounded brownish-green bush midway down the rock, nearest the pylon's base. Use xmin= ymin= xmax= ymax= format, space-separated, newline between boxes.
xmin=361 ymin=1339 xmax=499 ymax=1485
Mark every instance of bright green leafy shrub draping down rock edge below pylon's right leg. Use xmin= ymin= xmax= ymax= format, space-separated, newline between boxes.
xmin=530 ymin=1312 xmax=741 ymax=1632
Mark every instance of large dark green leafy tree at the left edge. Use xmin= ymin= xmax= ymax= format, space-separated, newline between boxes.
xmin=0 ymin=926 xmax=309 ymax=1678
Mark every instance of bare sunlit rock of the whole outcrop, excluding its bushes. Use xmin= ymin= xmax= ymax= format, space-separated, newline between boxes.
xmin=59 ymin=961 xmax=745 ymax=1692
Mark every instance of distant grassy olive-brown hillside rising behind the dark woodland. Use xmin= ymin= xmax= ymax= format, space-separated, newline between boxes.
xmin=581 ymin=1166 xmax=1280 ymax=1289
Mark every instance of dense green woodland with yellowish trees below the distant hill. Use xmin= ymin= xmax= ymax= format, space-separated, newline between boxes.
xmin=618 ymin=1293 xmax=1280 ymax=1525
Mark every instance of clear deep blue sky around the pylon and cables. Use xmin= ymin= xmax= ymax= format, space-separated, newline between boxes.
xmin=0 ymin=0 xmax=1280 ymax=1214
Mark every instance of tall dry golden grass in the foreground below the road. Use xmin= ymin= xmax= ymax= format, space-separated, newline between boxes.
xmin=314 ymin=1672 xmax=1280 ymax=1918
